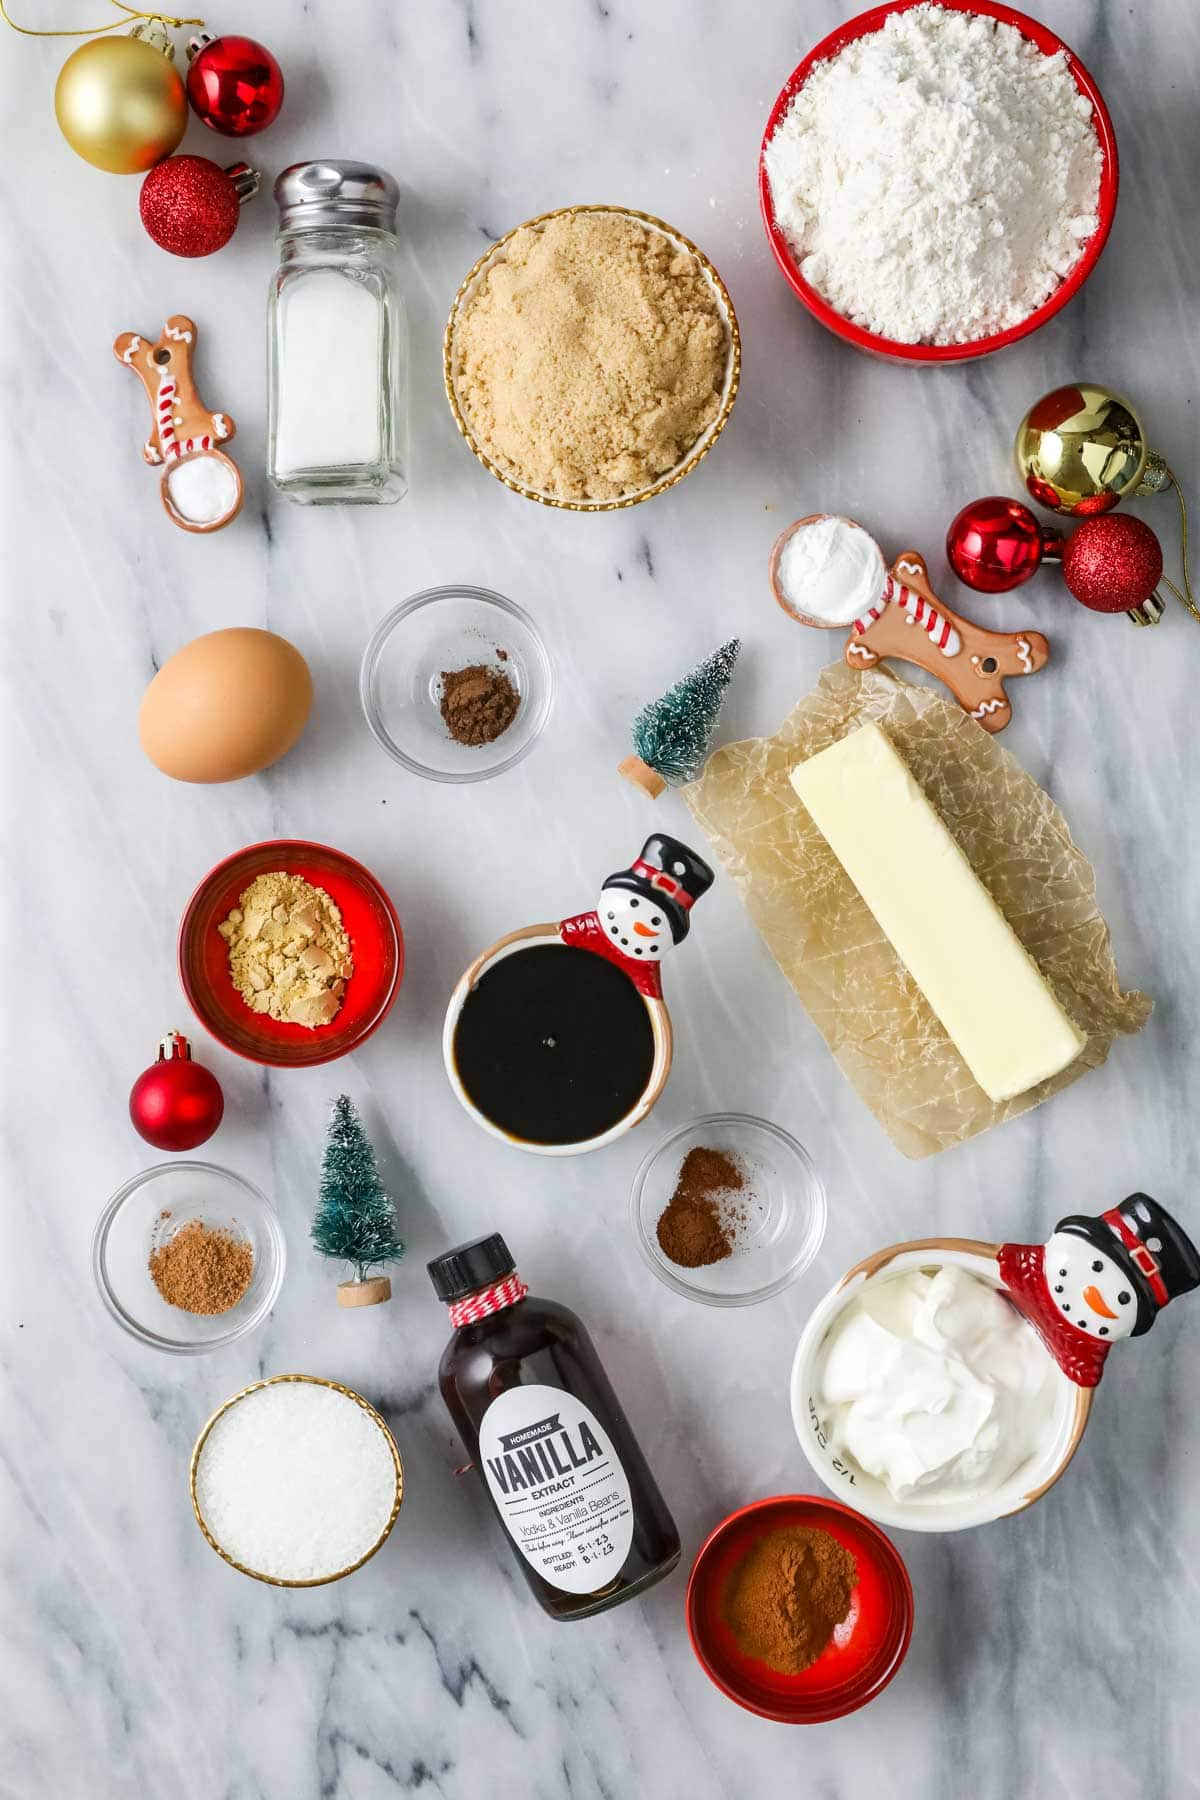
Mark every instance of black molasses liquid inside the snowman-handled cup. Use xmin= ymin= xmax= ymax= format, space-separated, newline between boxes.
xmin=453 ymin=943 xmax=655 ymax=1143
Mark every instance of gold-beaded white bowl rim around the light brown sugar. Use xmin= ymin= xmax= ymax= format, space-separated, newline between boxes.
xmin=443 ymin=203 xmax=741 ymax=513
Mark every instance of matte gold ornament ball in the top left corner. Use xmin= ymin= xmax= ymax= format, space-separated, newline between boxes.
xmin=54 ymin=38 xmax=187 ymax=175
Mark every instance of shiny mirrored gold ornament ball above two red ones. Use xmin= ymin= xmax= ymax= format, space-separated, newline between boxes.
xmin=1016 ymin=382 xmax=1160 ymax=517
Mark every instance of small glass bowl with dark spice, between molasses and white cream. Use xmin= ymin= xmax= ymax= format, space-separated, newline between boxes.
xmin=630 ymin=1112 xmax=826 ymax=1307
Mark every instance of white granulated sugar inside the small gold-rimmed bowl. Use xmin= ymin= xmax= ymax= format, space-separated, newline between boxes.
xmin=196 ymin=1381 xmax=396 ymax=1580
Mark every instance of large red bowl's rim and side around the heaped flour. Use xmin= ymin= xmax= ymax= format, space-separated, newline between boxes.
xmin=759 ymin=0 xmax=1117 ymax=364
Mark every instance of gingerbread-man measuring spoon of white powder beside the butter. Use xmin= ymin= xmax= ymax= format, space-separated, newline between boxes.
xmin=770 ymin=513 xmax=1051 ymax=731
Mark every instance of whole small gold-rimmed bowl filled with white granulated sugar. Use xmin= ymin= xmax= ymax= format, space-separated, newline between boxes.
xmin=189 ymin=1375 xmax=405 ymax=1588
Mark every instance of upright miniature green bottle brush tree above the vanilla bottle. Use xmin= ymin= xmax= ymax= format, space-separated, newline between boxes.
xmin=311 ymin=1094 xmax=405 ymax=1307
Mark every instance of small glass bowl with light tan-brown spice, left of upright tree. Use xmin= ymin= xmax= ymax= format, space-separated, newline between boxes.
xmin=92 ymin=1157 xmax=288 ymax=1355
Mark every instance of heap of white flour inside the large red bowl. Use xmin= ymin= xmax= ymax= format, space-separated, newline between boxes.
xmin=766 ymin=5 xmax=1103 ymax=344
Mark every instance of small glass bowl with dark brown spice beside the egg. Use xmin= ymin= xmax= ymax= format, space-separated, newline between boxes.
xmin=358 ymin=587 xmax=554 ymax=781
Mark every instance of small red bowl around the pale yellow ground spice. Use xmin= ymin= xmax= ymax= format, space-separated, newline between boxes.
xmin=178 ymin=837 xmax=405 ymax=1069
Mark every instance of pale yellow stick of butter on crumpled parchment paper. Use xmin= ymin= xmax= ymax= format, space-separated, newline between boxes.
xmin=792 ymin=725 xmax=1087 ymax=1103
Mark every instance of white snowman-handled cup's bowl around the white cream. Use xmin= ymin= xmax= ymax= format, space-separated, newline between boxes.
xmin=792 ymin=1238 xmax=1094 ymax=1532
